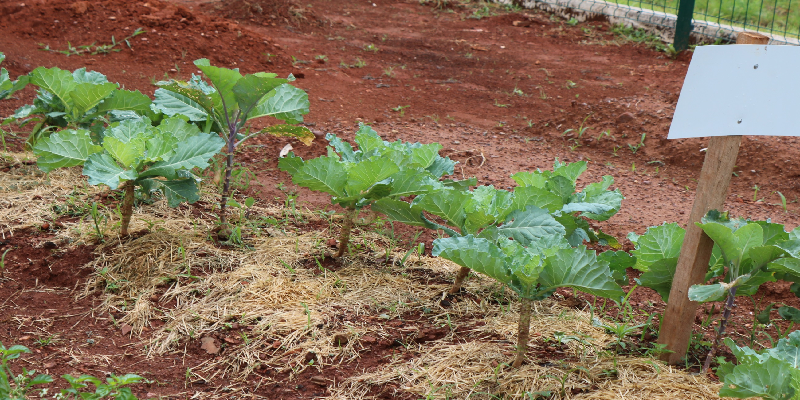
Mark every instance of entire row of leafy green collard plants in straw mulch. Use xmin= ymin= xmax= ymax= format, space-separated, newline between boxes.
xmin=0 ymin=47 xmax=800 ymax=399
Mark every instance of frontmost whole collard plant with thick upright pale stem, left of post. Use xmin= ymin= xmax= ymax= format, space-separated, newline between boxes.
xmin=433 ymin=234 xmax=625 ymax=368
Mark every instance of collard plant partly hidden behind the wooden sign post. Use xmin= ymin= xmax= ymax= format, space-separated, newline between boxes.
xmin=628 ymin=210 xmax=800 ymax=371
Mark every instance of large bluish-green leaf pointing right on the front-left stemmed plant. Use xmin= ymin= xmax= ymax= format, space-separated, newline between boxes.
xmin=141 ymin=133 xmax=225 ymax=179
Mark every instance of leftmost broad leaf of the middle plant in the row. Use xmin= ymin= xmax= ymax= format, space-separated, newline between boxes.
xmin=278 ymin=156 xmax=347 ymax=197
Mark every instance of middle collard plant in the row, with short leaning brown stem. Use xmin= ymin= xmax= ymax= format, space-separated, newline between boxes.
xmin=278 ymin=124 xmax=455 ymax=257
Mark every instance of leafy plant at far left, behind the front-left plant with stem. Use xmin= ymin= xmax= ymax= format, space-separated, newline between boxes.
xmin=11 ymin=67 xmax=153 ymax=148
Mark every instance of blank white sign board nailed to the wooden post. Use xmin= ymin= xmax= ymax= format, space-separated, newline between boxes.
xmin=667 ymin=45 xmax=800 ymax=139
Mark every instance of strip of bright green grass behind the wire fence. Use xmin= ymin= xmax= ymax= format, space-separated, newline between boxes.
xmin=609 ymin=0 xmax=800 ymax=37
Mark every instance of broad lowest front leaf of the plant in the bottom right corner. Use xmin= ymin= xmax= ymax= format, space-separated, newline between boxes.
xmin=719 ymin=358 xmax=795 ymax=400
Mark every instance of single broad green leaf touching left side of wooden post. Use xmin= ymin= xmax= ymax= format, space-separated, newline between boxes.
xmin=631 ymin=223 xmax=686 ymax=272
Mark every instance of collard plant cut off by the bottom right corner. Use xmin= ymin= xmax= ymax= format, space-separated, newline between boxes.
xmin=717 ymin=331 xmax=800 ymax=400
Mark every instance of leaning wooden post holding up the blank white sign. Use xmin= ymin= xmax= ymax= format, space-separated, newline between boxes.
xmin=658 ymin=32 xmax=769 ymax=364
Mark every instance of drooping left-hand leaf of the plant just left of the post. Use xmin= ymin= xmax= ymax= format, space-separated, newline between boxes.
xmin=431 ymin=235 xmax=511 ymax=284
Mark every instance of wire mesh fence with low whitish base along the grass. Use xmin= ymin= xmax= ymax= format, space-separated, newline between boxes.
xmin=499 ymin=0 xmax=800 ymax=45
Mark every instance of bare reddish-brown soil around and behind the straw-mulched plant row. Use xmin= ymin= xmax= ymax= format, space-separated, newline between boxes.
xmin=0 ymin=0 xmax=800 ymax=399
